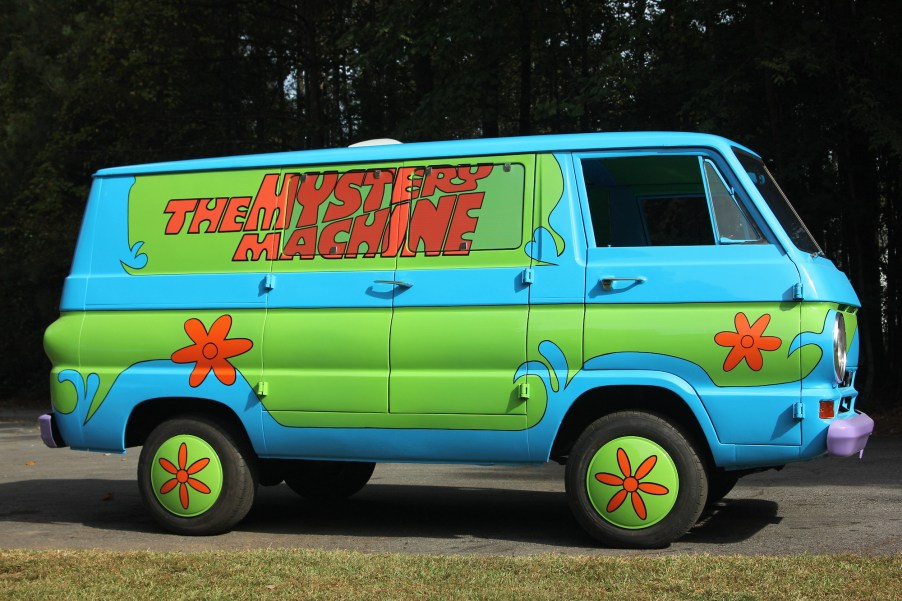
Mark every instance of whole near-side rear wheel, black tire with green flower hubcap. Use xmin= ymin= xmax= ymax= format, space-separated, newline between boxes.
xmin=138 ymin=415 xmax=257 ymax=536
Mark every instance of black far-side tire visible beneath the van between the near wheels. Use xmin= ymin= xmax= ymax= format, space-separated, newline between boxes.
xmin=285 ymin=461 xmax=376 ymax=503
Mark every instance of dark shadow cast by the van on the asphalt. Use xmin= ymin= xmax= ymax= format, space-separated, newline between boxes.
xmin=0 ymin=479 xmax=781 ymax=548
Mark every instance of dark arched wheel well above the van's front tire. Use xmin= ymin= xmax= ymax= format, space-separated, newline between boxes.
xmin=551 ymin=386 xmax=713 ymax=466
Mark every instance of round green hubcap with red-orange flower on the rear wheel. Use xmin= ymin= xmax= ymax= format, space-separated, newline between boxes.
xmin=150 ymin=434 xmax=222 ymax=518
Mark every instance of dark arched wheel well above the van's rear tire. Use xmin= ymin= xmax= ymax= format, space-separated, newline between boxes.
xmin=125 ymin=398 xmax=250 ymax=448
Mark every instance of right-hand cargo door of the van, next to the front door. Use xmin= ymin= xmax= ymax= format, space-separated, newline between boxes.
xmin=390 ymin=155 xmax=535 ymax=418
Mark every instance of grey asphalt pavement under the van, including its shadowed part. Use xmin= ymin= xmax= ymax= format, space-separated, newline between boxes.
xmin=0 ymin=411 xmax=902 ymax=555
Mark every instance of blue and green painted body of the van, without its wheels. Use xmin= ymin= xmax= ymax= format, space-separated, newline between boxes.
xmin=47 ymin=134 xmax=857 ymax=467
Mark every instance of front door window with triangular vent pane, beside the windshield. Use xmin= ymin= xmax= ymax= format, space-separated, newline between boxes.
xmin=581 ymin=155 xmax=763 ymax=247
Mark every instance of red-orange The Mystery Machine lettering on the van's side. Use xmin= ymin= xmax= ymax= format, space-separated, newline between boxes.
xmin=164 ymin=165 xmax=493 ymax=261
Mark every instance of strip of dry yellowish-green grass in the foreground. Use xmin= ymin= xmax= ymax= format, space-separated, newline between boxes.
xmin=0 ymin=550 xmax=902 ymax=601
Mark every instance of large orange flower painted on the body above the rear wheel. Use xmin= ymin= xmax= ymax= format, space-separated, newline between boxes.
xmin=172 ymin=315 xmax=254 ymax=387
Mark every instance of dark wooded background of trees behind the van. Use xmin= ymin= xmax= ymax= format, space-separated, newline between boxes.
xmin=0 ymin=0 xmax=902 ymax=406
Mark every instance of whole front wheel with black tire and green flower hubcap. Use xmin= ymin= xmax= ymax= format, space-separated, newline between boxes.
xmin=566 ymin=411 xmax=708 ymax=549
